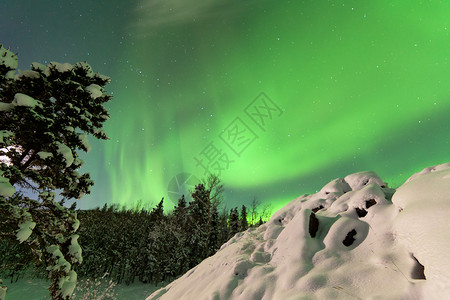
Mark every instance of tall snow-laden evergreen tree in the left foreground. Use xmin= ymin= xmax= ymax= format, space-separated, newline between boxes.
xmin=0 ymin=45 xmax=111 ymax=299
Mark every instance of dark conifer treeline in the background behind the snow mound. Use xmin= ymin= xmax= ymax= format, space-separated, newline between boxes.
xmin=0 ymin=177 xmax=270 ymax=284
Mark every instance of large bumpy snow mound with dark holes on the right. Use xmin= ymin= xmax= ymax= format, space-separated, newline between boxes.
xmin=147 ymin=163 xmax=450 ymax=300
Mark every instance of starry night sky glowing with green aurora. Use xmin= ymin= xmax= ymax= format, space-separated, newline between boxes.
xmin=0 ymin=0 xmax=450 ymax=209
